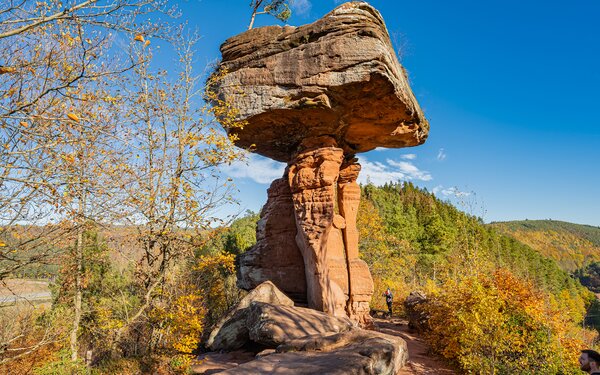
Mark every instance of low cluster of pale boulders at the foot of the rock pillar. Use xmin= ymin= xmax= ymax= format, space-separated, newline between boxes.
xmin=193 ymin=284 xmax=408 ymax=374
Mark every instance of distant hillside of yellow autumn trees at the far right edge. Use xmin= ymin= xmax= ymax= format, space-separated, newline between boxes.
xmin=491 ymin=220 xmax=600 ymax=272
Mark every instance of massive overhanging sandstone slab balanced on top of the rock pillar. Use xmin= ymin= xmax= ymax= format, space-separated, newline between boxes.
xmin=216 ymin=2 xmax=429 ymax=162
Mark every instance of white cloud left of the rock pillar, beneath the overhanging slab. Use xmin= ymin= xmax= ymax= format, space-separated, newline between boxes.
xmin=223 ymin=154 xmax=285 ymax=184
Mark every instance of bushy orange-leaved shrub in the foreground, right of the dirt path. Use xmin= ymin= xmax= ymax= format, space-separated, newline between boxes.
xmin=423 ymin=269 xmax=584 ymax=374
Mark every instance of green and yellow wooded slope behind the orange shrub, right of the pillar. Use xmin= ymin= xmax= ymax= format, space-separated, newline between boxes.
xmin=361 ymin=184 xmax=579 ymax=300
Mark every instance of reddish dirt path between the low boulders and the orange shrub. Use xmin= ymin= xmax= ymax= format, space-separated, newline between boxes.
xmin=375 ymin=318 xmax=458 ymax=375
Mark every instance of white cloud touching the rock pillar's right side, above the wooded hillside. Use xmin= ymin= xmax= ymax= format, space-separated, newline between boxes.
xmin=358 ymin=156 xmax=432 ymax=185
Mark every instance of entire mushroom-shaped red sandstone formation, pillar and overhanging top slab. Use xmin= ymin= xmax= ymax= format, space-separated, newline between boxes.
xmin=216 ymin=2 xmax=429 ymax=324
